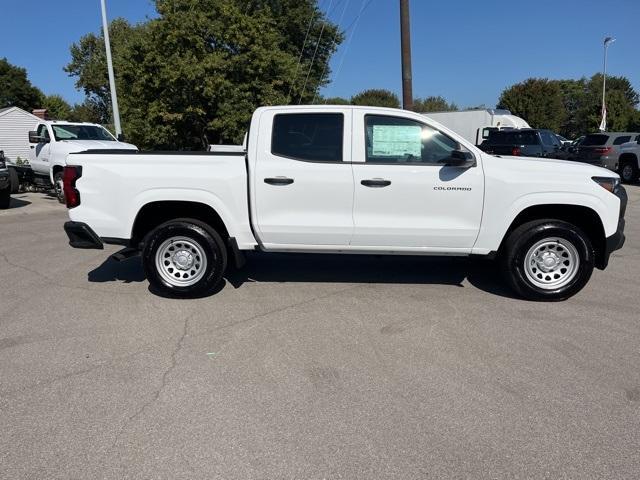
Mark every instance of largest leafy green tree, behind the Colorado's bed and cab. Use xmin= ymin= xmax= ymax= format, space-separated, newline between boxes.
xmin=66 ymin=0 xmax=342 ymax=149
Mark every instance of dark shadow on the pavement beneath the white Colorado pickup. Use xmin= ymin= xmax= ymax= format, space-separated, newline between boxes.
xmin=88 ymin=252 xmax=516 ymax=298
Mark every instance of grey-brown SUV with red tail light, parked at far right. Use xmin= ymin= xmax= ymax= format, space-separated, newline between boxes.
xmin=573 ymin=132 xmax=640 ymax=172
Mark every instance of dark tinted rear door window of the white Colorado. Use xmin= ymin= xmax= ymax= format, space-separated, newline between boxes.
xmin=271 ymin=113 xmax=344 ymax=162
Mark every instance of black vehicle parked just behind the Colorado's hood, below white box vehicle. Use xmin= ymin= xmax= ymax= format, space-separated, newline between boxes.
xmin=480 ymin=128 xmax=562 ymax=158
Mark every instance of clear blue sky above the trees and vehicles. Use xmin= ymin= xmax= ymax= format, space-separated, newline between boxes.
xmin=0 ymin=0 xmax=640 ymax=107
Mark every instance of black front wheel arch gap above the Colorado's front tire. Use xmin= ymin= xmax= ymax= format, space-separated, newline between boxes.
xmin=498 ymin=204 xmax=606 ymax=269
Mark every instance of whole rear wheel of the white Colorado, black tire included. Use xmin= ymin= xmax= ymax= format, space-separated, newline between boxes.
xmin=142 ymin=218 xmax=227 ymax=298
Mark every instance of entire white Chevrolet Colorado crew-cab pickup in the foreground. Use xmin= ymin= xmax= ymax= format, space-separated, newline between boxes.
xmin=64 ymin=106 xmax=626 ymax=300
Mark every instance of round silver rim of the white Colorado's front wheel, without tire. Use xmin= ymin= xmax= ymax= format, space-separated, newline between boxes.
xmin=524 ymin=237 xmax=580 ymax=290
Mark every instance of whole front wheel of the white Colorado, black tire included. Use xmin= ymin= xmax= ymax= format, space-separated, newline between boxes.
xmin=500 ymin=219 xmax=595 ymax=301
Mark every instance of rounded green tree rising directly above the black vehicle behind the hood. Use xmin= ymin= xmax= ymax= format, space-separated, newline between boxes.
xmin=498 ymin=78 xmax=565 ymax=131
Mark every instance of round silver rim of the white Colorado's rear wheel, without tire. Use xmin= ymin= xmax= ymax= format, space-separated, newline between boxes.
xmin=155 ymin=236 xmax=207 ymax=287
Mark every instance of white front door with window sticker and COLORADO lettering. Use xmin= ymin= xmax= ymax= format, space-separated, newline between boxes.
xmin=351 ymin=110 xmax=484 ymax=252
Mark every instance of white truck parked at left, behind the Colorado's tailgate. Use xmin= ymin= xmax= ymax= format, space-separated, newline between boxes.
xmin=29 ymin=120 xmax=137 ymax=203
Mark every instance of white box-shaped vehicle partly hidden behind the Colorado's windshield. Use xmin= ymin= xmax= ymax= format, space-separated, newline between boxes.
xmin=424 ymin=108 xmax=531 ymax=145
